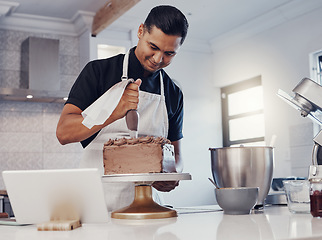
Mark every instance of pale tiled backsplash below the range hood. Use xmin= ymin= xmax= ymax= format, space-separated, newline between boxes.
xmin=0 ymin=101 xmax=82 ymax=189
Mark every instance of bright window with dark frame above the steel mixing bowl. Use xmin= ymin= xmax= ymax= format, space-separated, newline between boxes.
xmin=221 ymin=77 xmax=265 ymax=147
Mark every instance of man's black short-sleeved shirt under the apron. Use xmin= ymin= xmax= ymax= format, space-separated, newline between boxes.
xmin=65 ymin=48 xmax=183 ymax=147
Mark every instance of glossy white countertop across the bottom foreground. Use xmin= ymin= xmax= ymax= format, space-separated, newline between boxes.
xmin=0 ymin=205 xmax=322 ymax=240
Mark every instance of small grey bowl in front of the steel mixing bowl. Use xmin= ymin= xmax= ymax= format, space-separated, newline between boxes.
xmin=215 ymin=187 xmax=259 ymax=215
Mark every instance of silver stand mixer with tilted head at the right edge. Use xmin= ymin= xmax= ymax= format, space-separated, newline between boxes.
xmin=277 ymin=78 xmax=322 ymax=179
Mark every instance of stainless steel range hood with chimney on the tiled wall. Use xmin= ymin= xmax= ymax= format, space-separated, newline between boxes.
xmin=0 ymin=37 xmax=68 ymax=103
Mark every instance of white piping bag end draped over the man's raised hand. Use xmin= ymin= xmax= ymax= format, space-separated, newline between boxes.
xmin=82 ymin=79 xmax=136 ymax=130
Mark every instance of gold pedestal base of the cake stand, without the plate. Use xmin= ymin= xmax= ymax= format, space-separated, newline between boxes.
xmin=111 ymin=185 xmax=178 ymax=219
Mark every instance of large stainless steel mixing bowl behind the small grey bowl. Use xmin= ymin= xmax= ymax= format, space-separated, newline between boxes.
xmin=209 ymin=146 xmax=274 ymax=206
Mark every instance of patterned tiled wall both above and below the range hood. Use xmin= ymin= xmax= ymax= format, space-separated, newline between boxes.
xmin=0 ymin=30 xmax=82 ymax=190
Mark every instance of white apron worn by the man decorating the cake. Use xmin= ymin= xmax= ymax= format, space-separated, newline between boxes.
xmin=80 ymin=51 xmax=168 ymax=211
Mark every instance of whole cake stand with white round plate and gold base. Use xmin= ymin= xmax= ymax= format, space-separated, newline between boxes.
xmin=102 ymin=173 xmax=191 ymax=219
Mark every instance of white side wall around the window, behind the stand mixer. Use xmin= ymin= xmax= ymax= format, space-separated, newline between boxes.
xmin=213 ymin=6 xmax=322 ymax=177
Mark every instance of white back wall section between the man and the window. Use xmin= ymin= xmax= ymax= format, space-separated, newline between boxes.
xmin=158 ymin=43 xmax=222 ymax=206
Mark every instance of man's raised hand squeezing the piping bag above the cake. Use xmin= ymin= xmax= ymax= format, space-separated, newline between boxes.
xmin=110 ymin=79 xmax=142 ymax=121
